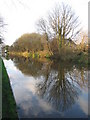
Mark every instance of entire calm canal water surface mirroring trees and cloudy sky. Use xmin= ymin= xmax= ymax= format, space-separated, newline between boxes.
xmin=3 ymin=58 xmax=88 ymax=118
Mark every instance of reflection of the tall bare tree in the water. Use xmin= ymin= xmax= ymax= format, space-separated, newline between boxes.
xmin=37 ymin=63 xmax=88 ymax=111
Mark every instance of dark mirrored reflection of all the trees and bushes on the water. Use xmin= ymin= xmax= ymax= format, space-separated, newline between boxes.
xmin=3 ymin=56 xmax=88 ymax=117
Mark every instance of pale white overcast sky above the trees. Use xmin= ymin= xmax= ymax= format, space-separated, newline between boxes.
xmin=0 ymin=0 xmax=89 ymax=45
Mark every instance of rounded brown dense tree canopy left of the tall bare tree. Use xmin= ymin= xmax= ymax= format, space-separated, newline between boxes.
xmin=10 ymin=33 xmax=43 ymax=52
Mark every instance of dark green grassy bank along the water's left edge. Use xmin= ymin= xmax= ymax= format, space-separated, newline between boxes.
xmin=2 ymin=58 xmax=18 ymax=119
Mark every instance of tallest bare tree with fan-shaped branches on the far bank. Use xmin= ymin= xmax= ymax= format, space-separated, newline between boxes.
xmin=49 ymin=4 xmax=81 ymax=47
